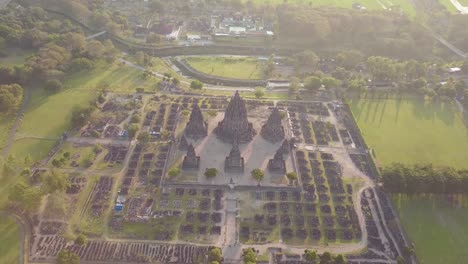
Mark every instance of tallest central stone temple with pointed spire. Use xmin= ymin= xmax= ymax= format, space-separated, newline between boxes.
xmin=215 ymin=91 xmax=257 ymax=144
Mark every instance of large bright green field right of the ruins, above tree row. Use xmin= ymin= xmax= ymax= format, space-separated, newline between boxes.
xmin=350 ymin=99 xmax=468 ymax=168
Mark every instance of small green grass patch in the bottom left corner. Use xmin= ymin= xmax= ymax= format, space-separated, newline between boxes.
xmin=0 ymin=214 xmax=21 ymax=264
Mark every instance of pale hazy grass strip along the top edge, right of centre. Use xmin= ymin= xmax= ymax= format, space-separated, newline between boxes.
xmin=247 ymin=0 xmax=414 ymax=15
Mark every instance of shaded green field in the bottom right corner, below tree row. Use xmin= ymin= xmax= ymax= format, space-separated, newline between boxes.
xmin=393 ymin=196 xmax=468 ymax=264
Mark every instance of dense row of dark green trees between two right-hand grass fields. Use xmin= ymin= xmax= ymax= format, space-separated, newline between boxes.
xmin=381 ymin=163 xmax=468 ymax=194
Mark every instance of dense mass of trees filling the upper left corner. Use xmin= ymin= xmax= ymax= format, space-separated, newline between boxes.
xmin=0 ymin=6 xmax=117 ymax=112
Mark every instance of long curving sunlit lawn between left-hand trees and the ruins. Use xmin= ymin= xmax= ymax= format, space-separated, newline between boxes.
xmin=8 ymin=63 xmax=157 ymax=160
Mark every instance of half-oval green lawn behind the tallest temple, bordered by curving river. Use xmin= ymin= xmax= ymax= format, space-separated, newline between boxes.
xmin=187 ymin=57 xmax=263 ymax=79
